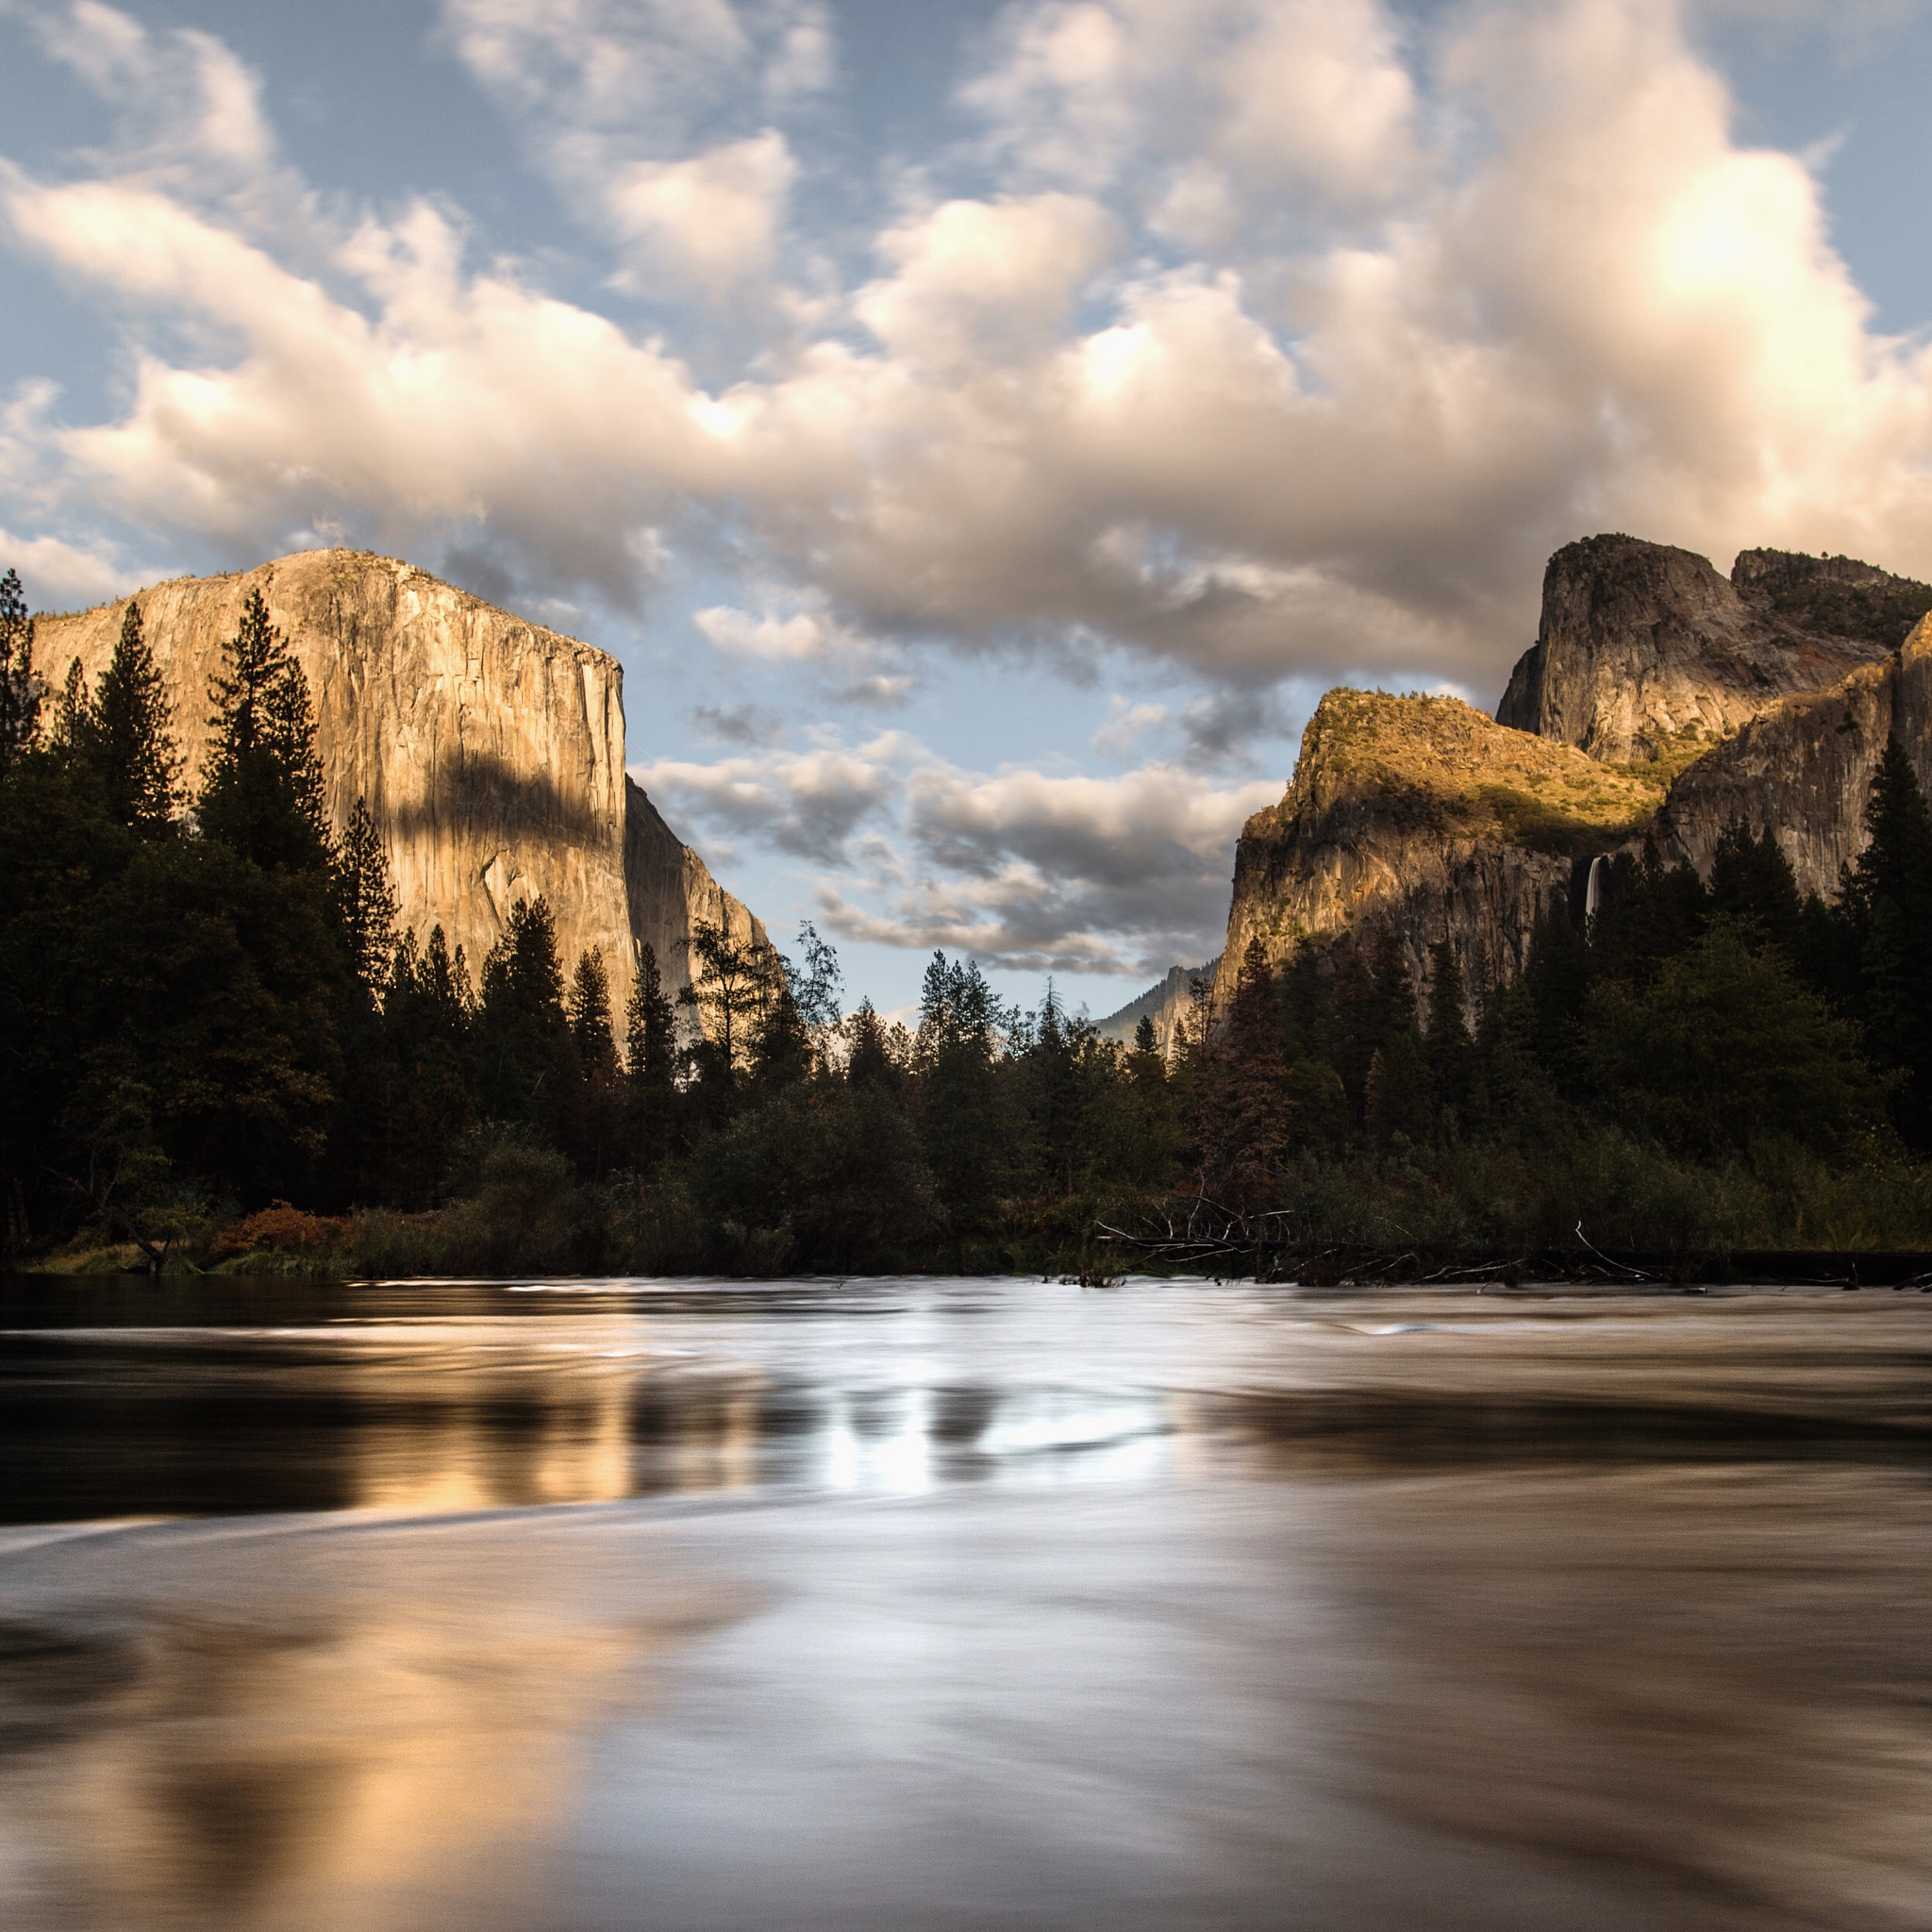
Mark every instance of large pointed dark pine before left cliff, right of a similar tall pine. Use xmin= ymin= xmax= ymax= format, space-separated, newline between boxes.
xmin=197 ymin=590 xmax=330 ymax=872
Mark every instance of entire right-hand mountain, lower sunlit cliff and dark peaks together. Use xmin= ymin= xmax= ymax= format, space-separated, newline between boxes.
xmin=1215 ymin=535 xmax=1932 ymax=1005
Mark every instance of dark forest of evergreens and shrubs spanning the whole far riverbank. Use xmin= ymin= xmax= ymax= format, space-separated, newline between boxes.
xmin=0 ymin=572 xmax=1932 ymax=1279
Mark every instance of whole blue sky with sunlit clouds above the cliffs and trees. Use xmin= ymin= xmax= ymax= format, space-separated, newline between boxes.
xmin=0 ymin=0 xmax=1932 ymax=1014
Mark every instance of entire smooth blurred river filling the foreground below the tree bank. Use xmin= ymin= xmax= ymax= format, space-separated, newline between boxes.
xmin=0 ymin=1279 xmax=1932 ymax=1932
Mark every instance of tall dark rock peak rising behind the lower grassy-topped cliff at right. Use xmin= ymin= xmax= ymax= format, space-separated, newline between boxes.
xmin=1495 ymin=535 xmax=1893 ymax=763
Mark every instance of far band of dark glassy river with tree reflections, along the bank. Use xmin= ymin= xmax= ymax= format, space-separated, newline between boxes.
xmin=0 ymin=1283 xmax=1932 ymax=1521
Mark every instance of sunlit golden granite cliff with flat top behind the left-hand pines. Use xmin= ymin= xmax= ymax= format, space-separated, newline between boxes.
xmin=35 ymin=551 xmax=763 ymax=1020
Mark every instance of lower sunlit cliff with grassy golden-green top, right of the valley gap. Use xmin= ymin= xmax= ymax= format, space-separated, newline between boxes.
xmin=1215 ymin=690 xmax=1663 ymax=1008
